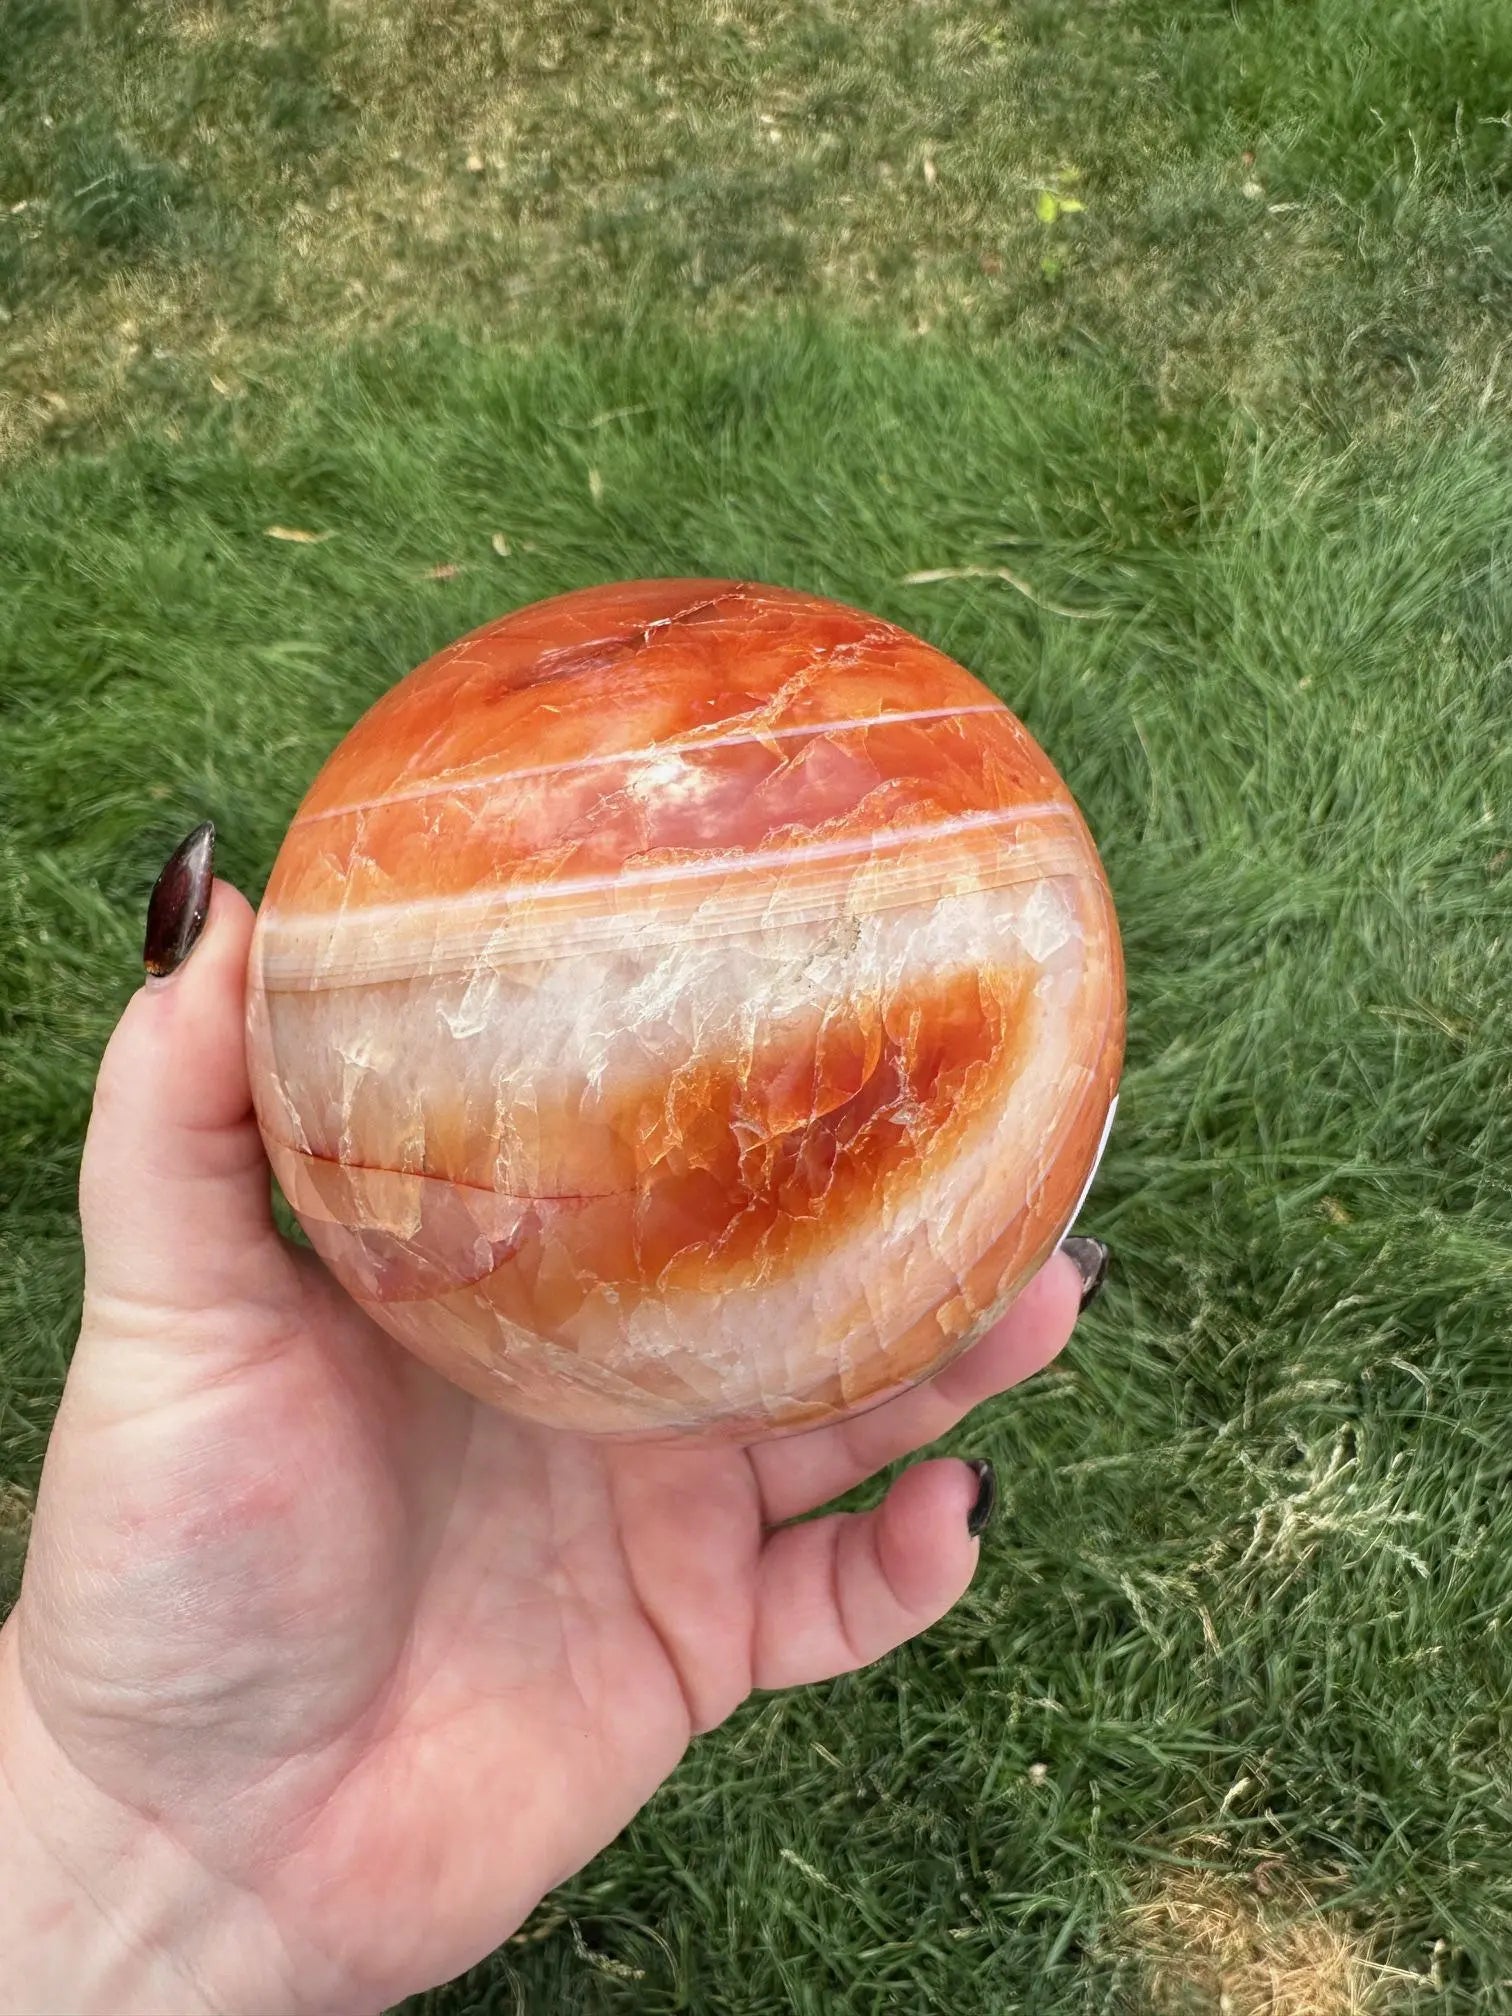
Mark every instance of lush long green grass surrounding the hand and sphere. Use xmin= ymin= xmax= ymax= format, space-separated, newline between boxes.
xmin=0 ymin=327 xmax=1512 ymax=2016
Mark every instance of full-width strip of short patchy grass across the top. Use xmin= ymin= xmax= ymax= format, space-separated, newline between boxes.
xmin=0 ymin=0 xmax=1512 ymax=450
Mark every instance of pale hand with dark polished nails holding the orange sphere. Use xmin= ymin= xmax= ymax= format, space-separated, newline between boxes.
xmin=0 ymin=829 xmax=1107 ymax=2016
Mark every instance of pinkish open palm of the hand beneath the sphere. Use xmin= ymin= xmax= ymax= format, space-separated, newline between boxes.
xmin=28 ymin=1256 xmax=762 ymax=1996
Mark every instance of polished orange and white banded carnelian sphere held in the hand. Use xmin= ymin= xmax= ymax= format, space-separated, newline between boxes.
xmin=248 ymin=581 xmax=1123 ymax=1439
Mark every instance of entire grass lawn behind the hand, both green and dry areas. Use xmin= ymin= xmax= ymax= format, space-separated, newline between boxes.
xmin=0 ymin=0 xmax=1512 ymax=2016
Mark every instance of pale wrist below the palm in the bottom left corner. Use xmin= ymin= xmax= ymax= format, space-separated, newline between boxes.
xmin=0 ymin=1615 xmax=304 ymax=2016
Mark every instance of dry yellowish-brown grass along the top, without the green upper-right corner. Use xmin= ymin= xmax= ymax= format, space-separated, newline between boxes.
xmin=11 ymin=0 xmax=1494 ymax=454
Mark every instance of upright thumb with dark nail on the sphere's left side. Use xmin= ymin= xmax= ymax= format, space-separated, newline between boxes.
xmin=79 ymin=825 xmax=288 ymax=1331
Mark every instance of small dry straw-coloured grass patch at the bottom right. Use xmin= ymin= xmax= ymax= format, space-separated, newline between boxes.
xmin=1129 ymin=1863 xmax=1403 ymax=2016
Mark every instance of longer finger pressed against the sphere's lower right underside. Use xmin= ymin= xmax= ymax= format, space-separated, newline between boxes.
xmin=748 ymin=1252 xmax=1083 ymax=1526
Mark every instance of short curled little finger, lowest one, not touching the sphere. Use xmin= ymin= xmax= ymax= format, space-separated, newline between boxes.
xmin=752 ymin=1458 xmax=982 ymax=1687
